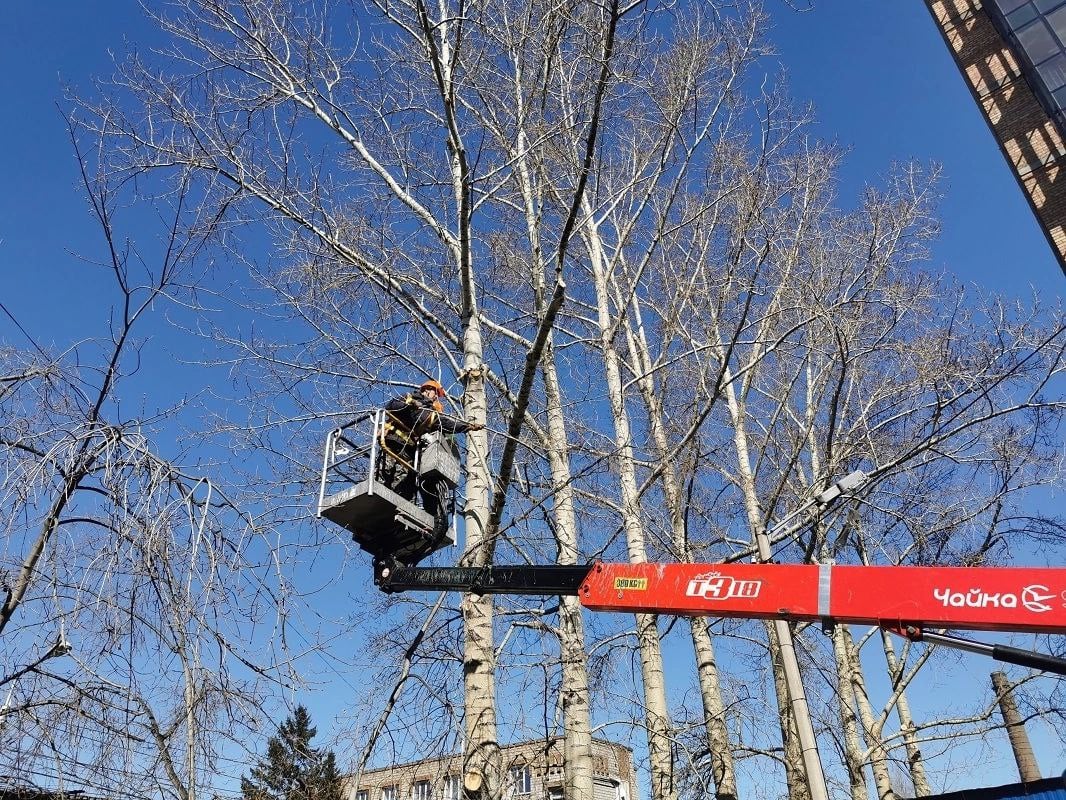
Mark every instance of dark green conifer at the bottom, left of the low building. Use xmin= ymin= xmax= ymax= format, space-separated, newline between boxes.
xmin=241 ymin=705 xmax=341 ymax=800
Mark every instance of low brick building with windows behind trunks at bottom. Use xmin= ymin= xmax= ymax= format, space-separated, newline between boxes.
xmin=342 ymin=737 xmax=637 ymax=800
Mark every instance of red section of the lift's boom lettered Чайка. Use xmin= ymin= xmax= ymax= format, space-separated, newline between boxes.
xmin=578 ymin=563 xmax=1066 ymax=634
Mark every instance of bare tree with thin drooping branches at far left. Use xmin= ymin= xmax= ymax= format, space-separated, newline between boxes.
xmin=0 ymin=139 xmax=291 ymax=800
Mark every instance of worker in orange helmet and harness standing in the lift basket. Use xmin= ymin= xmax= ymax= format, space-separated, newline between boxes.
xmin=382 ymin=380 xmax=485 ymax=535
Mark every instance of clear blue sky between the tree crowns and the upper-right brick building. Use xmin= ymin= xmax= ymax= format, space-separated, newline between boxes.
xmin=771 ymin=0 xmax=1064 ymax=299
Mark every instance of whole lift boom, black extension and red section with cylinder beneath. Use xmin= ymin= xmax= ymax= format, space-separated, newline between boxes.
xmin=374 ymin=560 xmax=1066 ymax=675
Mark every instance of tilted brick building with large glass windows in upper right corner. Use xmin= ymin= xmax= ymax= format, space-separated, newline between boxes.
xmin=925 ymin=0 xmax=1066 ymax=272
